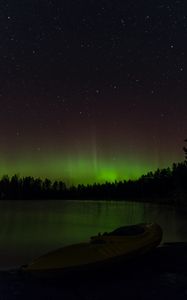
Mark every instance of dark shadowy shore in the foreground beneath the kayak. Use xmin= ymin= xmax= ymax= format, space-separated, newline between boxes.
xmin=0 ymin=243 xmax=187 ymax=300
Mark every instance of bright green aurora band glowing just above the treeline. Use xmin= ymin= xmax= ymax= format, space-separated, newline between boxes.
xmin=0 ymin=155 xmax=176 ymax=185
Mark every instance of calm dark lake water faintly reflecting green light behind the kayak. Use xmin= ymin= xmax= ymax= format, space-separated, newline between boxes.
xmin=0 ymin=201 xmax=187 ymax=269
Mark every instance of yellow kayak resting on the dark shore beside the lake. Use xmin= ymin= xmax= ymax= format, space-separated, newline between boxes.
xmin=22 ymin=223 xmax=162 ymax=272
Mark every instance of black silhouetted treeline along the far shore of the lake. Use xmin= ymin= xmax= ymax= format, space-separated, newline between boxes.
xmin=0 ymin=139 xmax=187 ymax=205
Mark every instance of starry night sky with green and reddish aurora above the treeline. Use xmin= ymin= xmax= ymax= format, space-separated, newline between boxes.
xmin=0 ymin=0 xmax=187 ymax=184
